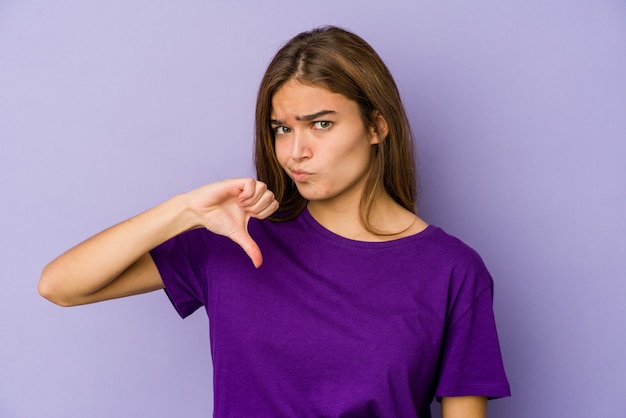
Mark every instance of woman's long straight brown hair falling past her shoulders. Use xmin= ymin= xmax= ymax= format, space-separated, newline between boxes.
xmin=255 ymin=26 xmax=417 ymax=232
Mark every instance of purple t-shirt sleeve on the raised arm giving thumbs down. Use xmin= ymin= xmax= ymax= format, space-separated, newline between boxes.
xmin=150 ymin=229 xmax=209 ymax=318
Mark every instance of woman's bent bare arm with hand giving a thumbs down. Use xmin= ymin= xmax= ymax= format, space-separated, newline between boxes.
xmin=39 ymin=179 xmax=278 ymax=306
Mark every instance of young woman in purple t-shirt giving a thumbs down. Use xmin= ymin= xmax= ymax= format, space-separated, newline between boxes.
xmin=39 ymin=27 xmax=509 ymax=418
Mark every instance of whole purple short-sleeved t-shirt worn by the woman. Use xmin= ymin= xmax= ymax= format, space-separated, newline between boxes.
xmin=151 ymin=210 xmax=510 ymax=418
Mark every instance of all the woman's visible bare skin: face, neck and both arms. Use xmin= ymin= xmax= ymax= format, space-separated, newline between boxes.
xmin=39 ymin=81 xmax=487 ymax=418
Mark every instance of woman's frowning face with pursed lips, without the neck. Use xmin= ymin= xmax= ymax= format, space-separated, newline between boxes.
xmin=271 ymin=80 xmax=378 ymax=204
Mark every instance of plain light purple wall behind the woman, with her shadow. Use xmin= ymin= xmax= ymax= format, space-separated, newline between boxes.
xmin=0 ymin=0 xmax=626 ymax=418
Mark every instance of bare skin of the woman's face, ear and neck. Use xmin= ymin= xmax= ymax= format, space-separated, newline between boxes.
xmin=271 ymin=80 xmax=427 ymax=241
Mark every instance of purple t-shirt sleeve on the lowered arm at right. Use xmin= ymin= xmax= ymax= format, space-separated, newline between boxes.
xmin=435 ymin=250 xmax=511 ymax=399
